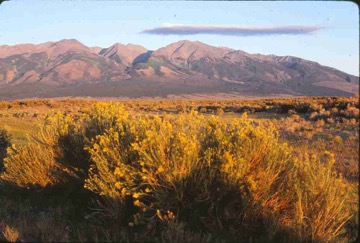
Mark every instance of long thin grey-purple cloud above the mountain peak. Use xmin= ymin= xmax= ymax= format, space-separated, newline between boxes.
xmin=141 ymin=24 xmax=324 ymax=36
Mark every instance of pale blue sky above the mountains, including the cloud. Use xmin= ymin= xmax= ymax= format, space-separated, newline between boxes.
xmin=0 ymin=0 xmax=359 ymax=76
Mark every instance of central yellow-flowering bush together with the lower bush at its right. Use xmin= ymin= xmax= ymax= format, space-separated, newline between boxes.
xmin=85 ymin=110 xmax=356 ymax=242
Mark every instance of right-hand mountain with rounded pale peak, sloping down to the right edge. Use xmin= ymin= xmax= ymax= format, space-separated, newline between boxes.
xmin=132 ymin=41 xmax=358 ymax=93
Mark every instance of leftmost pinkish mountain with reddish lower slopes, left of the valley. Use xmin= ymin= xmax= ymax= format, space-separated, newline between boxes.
xmin=0 ymin=40 xmax=126 ymax=85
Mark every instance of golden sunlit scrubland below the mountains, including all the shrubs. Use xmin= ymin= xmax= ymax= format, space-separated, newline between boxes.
xmin=0 ymin=96 xmax=359 ymax=242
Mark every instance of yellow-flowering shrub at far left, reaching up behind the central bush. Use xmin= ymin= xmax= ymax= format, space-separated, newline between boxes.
xmin=3 ymin=103 xmax=126 ymax=187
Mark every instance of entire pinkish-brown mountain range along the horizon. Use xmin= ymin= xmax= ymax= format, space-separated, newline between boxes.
xmin=0 ymin=39 xmax=359 ymax=99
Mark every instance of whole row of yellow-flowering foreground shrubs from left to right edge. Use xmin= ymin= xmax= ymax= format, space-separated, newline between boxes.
xmin=2 ymin=103 xmax=358 ymax=242
